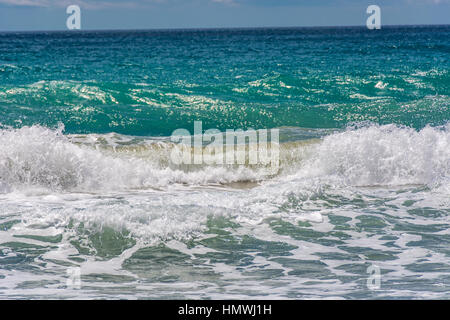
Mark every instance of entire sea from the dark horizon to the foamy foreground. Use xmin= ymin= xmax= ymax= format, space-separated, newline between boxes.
xmin=0 ymin=26 xmax=450 ymax=299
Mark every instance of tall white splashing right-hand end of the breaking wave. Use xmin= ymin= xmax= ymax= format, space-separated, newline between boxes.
xmin=296 ymin=124 xmax=450 ymax=186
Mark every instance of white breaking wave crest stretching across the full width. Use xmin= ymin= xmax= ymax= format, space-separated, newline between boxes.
xmin=0 ymin=125 xmax=450 ymax=193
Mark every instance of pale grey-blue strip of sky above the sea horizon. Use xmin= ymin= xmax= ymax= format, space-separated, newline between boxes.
xmin=0 ymin=0 xmax=450 ymax=31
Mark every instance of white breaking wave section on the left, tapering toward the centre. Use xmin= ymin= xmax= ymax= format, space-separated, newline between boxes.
xmin=0 ymin=126 xmax=274 ymax=192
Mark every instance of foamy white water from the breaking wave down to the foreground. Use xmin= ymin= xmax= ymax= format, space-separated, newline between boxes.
xmin=0 ymin=126 xmax=450 ymax=298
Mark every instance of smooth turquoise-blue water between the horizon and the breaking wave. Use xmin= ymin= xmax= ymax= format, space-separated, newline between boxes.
xmin=0 ymin=26 xmax=450 ymax=136
